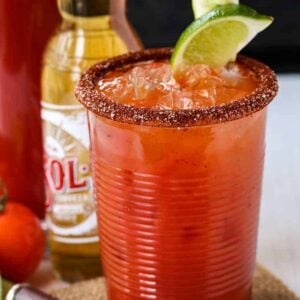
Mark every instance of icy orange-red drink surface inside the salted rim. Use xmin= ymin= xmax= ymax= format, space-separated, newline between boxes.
xmin=98 ymin=61 xmax=257 ymax=109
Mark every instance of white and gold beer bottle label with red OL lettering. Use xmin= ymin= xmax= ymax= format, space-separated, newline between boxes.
xmin=42 ymin=102 xmax=98 ymax=244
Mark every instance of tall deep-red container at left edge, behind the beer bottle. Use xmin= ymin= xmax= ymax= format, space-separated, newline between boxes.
xmin=0 ymin=0 xmax=58 ymax=218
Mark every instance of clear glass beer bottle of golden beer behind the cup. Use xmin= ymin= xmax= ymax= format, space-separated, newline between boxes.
xmin=42 ymin=0 xmax=141 ymax=281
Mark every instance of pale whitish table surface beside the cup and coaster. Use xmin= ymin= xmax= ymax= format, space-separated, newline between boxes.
xmin=30 ymin=74 xmax=300 ymax=295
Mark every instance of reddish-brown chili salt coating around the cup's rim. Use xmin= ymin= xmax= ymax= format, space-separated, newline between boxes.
xmin=75 ymin=48 xmax=278 ymax=127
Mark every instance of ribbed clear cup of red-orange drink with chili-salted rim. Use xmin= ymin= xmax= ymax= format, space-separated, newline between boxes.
xmin=76 ymin=49 xmax=277 ymax=300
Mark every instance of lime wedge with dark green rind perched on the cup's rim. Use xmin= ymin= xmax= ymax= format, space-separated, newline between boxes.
xmin=171 ymin=4 xmax=273 ymax=72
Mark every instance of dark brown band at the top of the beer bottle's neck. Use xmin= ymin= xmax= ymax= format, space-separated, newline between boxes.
xmin=58 ymin=0 xmax=109 ymax=17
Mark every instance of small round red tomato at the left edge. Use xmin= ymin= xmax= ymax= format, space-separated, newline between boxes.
xmin=0 ymin=182 xmax=45 ymax=282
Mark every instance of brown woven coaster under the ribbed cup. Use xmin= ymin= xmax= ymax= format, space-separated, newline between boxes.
xmin=51 ymin=267 xmax=300 ymax=300
